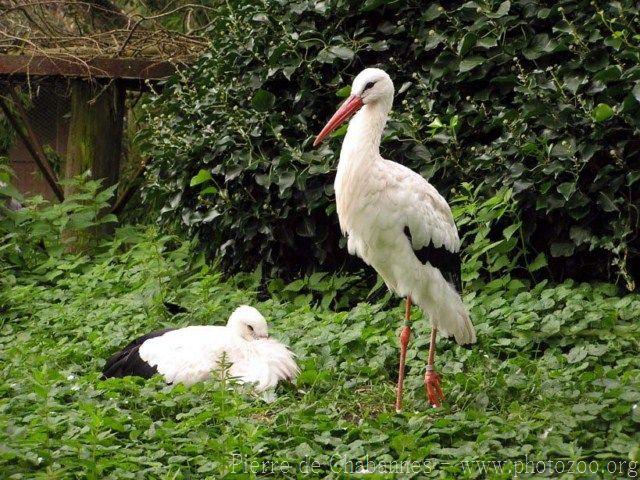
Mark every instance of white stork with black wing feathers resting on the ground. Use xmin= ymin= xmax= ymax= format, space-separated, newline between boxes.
xmin=103 ymin=305 xmax=299 ymax=392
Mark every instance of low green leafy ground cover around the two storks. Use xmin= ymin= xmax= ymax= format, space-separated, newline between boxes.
xmin=0 ymin=230 xmax=640 ymax=479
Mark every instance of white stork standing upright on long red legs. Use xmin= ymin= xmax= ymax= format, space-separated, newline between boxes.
xmin=313 ymin=68 xmax=476 ymax=411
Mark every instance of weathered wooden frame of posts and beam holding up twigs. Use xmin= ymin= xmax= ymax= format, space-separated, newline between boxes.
xmin=0 ymin=54 xmax=185 ymax=219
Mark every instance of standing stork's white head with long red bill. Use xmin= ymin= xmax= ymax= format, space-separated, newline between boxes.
xmin=313 ymin=68 xmax=393 ymax=147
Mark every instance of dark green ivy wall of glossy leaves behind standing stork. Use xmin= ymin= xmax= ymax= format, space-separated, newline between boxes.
xmin=139 ymin=0 xmax=640 ymax=288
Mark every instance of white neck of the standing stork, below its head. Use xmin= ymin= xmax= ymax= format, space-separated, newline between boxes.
xmin=340 ymin=97 xmax=393 ymax=163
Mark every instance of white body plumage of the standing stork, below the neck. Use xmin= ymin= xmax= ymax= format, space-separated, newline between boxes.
xmin=335 ymin=158 xmax=475 ymax=344
